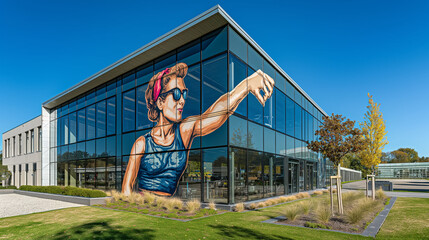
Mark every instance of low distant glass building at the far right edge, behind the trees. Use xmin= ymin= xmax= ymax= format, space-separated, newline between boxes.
xmin=377 ymin=162 xmax=429 ymax=179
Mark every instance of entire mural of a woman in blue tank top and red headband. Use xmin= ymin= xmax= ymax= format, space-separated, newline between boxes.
xmin=122 ymin=63 xmax=275 ymax=196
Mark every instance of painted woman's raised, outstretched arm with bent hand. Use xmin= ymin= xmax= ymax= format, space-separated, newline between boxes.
xmin=183 ymin=70 xmax=275 ymax=139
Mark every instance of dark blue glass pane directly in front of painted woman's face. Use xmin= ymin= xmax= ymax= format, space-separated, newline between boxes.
xmin=182 ymin=64 xmax=201 ymax=119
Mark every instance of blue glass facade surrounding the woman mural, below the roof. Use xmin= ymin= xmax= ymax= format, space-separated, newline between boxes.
xmin=50 ymin=26 xmax=326 ymax=203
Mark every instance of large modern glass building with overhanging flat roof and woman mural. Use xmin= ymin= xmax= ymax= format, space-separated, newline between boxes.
xmin=42 ymin=6 xmax=327 ymax=204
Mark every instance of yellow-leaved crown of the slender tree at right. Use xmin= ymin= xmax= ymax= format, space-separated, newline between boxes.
xmin=360 ymin=93 xmax=388 ymax=172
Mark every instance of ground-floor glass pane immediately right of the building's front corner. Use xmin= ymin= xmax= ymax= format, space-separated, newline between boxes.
xmin=230 ymin=148 xmax=247 ymax=203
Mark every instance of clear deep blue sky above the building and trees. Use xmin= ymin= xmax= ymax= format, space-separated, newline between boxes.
xmin=0 ymin=0 xmax=429 ymax=156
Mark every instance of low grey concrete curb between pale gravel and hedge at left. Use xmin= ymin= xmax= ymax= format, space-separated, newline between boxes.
xmin=0 ymin=189 xmax=111 ymax=206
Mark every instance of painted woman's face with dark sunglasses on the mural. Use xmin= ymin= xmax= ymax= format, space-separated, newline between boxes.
xmin=156 ymin=78 xmax=188 ymax=122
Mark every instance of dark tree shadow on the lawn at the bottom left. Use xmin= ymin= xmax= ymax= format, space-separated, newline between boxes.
xmin=52 ymin=221 xmax=155 ymax=240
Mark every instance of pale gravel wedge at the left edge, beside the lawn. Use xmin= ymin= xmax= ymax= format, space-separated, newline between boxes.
xmin=0 ymin=193 xmax=84 ymax=218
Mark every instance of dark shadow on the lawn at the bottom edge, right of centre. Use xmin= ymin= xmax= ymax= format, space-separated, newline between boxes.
xmin=208 ymin=225 xmax=292 ymax=240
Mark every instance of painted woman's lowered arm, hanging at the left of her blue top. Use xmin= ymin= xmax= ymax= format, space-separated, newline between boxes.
xmin=122 ymin=136 xmax=146 ymax=196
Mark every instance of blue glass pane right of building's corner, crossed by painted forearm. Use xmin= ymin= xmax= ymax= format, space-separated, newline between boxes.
xmin=229 ymin=54 xmax=247 ymax=116
